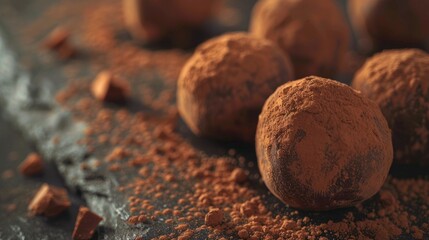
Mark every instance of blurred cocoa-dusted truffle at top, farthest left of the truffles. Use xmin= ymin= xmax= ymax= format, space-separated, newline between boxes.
xmin=123 ymin=0 xmax=220 ymax=42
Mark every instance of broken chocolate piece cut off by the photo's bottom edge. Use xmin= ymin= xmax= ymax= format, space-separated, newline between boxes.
xmin=72 ymin=207 xmax=103 ymax=240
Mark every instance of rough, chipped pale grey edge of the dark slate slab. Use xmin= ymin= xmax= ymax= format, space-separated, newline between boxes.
xmin=0 ymin=19 xmax=135 ymax=239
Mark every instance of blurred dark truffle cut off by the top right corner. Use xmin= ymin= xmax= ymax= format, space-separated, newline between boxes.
xmin=349 ymin=0 xmax=429 ymax=51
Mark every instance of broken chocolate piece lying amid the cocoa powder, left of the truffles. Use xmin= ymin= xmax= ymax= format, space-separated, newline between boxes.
xmin=91 ymin=71 xmax=131 ymax=102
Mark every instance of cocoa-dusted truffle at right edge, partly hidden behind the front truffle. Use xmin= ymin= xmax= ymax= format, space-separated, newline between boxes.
xmin=352 ymin=49 xmax=429 ymax=165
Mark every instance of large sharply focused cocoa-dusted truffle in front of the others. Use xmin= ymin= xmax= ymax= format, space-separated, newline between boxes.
xmin=256 ymin=76 xmax=393 ymax=211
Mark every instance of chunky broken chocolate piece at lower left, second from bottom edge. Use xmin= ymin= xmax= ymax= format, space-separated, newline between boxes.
xmin=28 ymin=183 xmax=71 ymax=217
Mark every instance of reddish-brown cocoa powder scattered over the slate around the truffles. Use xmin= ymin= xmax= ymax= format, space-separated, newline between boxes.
xmin=6 ymin=0 xmax=429 ymax=239
